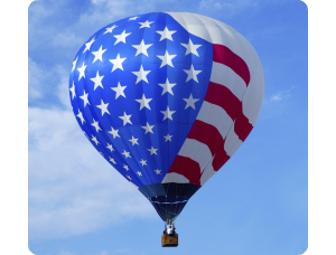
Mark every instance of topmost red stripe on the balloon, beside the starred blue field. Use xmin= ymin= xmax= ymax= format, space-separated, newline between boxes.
xmin=213 ymin=44 xmax=250 ymax=86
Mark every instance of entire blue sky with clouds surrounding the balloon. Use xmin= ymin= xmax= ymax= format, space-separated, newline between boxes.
xmin=29 ymin=0 xmax=307 ymax=255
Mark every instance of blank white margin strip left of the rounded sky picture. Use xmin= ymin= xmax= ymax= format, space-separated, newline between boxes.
xmin=0 ymin=0 xmax=32 ymax=254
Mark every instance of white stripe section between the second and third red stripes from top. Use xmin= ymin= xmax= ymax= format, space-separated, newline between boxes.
xmin=197 ymin=101 xmax=233 ymax=138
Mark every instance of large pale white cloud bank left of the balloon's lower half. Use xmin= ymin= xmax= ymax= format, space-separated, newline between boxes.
xmin=29 ymin=108 xmax=155 ymax=240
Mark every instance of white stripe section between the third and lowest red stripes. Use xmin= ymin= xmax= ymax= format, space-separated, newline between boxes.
xmin=178 ymin=138 xmax=212 ymax=171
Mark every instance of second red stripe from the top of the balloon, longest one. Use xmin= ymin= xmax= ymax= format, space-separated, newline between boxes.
xmin=205 ymin=82 xmax=253 ymax=141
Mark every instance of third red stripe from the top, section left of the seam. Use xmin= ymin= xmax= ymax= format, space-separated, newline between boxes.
xmin=188 ymin=120 xmax=224 ymax=155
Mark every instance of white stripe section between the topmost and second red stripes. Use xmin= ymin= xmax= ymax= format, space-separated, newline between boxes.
xmin=210 ymin=62 xmax=246 ymax=101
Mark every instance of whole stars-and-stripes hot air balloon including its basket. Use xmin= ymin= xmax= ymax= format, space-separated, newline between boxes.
xmin=69 ymin=12 xmax=263 ymax=246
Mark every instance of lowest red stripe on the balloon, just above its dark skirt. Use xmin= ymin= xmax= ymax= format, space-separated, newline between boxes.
xmin=169 ymin=155 xmax=201 ymax=186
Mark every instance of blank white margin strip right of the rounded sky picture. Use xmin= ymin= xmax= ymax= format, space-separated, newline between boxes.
xmin=304 ymin=0 xmax=336 ymax=255
